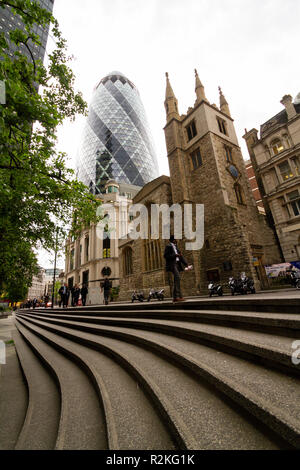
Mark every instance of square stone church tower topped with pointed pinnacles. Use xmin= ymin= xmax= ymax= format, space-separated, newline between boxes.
xmin=164 ymin=70 xmax=280 ymax=292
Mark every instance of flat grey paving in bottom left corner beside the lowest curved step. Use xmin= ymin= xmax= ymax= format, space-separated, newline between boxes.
xmin=0 ymin=345 xmax=28 ymax=450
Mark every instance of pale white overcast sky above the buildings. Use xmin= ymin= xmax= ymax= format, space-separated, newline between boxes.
xmin=38 ymin=0 xmax=300 ymax=267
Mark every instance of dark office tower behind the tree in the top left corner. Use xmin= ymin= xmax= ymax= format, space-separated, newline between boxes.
xmin=0 ymin=0 xmax=54 ymax=62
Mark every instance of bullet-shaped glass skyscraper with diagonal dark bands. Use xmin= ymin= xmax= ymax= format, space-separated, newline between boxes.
xmin=77 ymin=72 xmax=159 ymax=194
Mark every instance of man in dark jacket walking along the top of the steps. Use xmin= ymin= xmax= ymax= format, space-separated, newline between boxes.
xmin=164 ymin=235 xmax=188 ymax=302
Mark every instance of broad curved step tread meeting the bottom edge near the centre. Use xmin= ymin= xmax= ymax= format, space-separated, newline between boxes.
xmin=15 ymin=320 xmax=175 ymax=450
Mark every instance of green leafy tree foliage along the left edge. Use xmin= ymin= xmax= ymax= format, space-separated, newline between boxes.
xmin=0 ymin=0 xmax=99 ymax=300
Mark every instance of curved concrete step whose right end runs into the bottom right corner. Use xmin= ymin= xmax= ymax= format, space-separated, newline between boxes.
xmin=16 ymin=318 xmax=300 ymax=448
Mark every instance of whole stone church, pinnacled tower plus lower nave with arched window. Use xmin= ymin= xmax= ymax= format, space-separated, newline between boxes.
xmin=119 ymin=71 xmax=280 ymax=298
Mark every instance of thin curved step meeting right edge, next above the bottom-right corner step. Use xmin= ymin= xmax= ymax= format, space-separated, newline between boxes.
xmin=19 ymin=314 xmax=300 ymax=375
